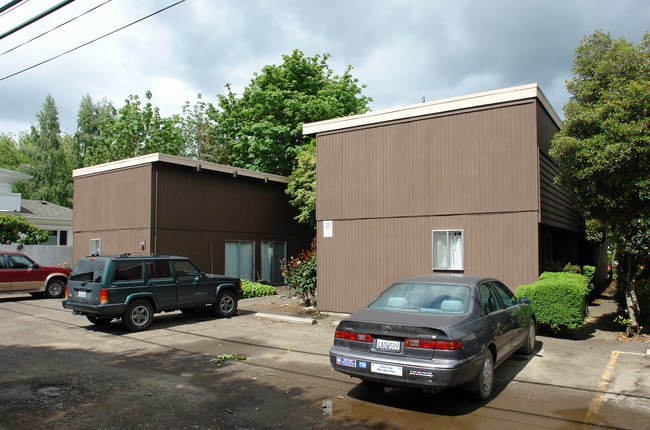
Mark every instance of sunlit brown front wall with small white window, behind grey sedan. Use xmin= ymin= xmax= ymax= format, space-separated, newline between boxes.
xmin=317 ymin=99 xmax=540 ymax=312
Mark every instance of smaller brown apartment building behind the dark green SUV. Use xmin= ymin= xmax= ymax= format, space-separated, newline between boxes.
xmin=73 ymin=153 xmax=314 ymax=283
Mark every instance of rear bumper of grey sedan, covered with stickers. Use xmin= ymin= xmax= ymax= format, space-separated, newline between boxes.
xmin=330 ymin=346 xmax=480 ymax=388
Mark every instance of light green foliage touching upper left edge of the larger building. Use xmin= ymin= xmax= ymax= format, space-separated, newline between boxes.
xmin=286 ymin=142 xmax=316 ymax=228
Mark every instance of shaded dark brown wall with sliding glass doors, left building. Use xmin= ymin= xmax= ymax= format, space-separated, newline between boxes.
xmin=153 ymin=163 xmax=314 ymax=277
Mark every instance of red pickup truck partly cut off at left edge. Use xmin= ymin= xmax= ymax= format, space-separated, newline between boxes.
xmin=0 ymin=252 xmax=70 ymax=299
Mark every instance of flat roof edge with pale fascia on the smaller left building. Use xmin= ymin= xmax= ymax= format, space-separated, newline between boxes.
xmin=72 ymin=152 xmax=289 ymax=184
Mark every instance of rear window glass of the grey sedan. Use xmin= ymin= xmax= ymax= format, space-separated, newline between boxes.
xmin=368 ymin=284 xmax=471 ymax=314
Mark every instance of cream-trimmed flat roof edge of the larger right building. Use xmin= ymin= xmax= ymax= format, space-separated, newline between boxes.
xmin=302 ymin=84 xmax=560 ymax=136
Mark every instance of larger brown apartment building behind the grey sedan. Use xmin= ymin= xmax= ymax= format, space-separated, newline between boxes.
xmin=303 ymin=84 xmax=595 ymax=312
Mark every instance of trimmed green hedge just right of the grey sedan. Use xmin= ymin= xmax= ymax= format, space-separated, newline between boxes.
xmin=516 ymin=272 xmax=589 ymax=334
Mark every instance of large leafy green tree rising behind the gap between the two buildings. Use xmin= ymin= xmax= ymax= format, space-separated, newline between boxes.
xmin=208 ymin=50 xmax=372 ymax=176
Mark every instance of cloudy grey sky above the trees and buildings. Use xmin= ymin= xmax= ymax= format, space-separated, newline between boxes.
xmin=0 ymin=0 xmax=650 ymax=136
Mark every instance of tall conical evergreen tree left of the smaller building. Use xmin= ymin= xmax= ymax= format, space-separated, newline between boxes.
xmin=15 ymin=94 xmax=72 ymax=207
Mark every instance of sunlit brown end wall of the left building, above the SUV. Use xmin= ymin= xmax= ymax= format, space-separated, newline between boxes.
xmin=73 ymin=164 xmax=153 ymax=261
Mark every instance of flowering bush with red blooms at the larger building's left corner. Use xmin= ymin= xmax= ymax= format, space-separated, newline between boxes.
xmin=282 ymin=238 xmax=316 ymax=306
